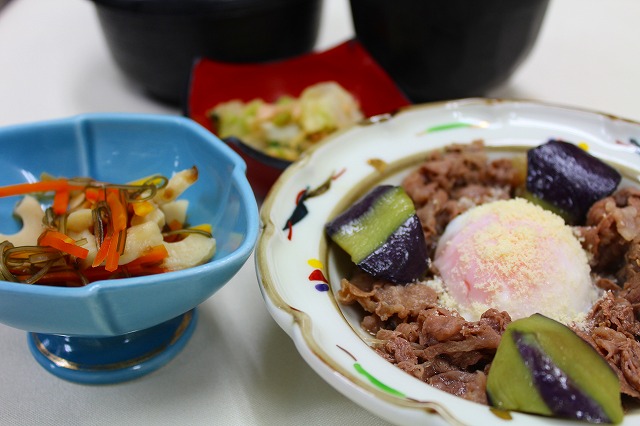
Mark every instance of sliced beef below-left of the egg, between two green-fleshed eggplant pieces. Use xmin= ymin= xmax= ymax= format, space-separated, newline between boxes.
xmin=338 ymin=271 xmax=511 ymax=404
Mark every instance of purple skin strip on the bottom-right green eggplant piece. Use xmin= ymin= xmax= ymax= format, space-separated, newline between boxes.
xmin=513 ymin=331 xmax=611 ymax=423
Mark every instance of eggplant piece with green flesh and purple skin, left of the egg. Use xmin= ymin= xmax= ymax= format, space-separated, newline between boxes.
xmin=325 ymin=185 xmax=429 ymax=283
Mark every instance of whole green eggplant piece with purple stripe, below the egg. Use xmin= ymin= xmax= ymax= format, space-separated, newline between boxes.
xmin=487 ymin=314 xmax=623 ymax=423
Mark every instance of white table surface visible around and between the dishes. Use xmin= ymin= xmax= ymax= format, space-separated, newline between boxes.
xmin=0 ymin=0 xmax=640 ymax=426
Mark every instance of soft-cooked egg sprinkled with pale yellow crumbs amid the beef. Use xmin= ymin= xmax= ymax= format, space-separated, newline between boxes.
xmin=434 ymin=198 xmax=600 ymax=324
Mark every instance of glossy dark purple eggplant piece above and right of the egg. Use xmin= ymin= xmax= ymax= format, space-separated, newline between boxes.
xmin=526 ymin=140 xmax=622 ymax=225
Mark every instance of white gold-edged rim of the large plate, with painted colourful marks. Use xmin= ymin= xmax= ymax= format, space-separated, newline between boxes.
xmin=256 ymin=99 xmax=640 ymax=426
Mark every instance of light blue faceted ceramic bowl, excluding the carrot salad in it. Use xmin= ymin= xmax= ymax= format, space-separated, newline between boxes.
xmin=0 ymin=114 xmax=259 ymax=382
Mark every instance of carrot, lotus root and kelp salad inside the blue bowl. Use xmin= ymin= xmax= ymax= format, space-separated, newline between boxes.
xmin=0 ymin=166 xmax=216 ymax=287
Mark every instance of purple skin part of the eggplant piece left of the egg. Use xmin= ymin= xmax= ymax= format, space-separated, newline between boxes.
xmin=358 ymin=215 xmax=429 ymax=284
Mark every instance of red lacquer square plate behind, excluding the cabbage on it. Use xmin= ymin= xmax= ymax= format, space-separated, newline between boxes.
xmin=185 ymin=40 xmax=410 ymax=200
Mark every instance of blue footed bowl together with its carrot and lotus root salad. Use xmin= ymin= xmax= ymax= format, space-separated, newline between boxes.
xmin=0 ymin=114 xmax=259 ymax=384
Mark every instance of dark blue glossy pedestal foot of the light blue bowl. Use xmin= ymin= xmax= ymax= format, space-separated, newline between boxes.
xmin=28 ymin=309 xmax=197 ymax=384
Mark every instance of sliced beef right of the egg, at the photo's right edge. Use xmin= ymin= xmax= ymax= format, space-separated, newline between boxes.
xmin=576 ymin=187 xmax=640 ymax=398
